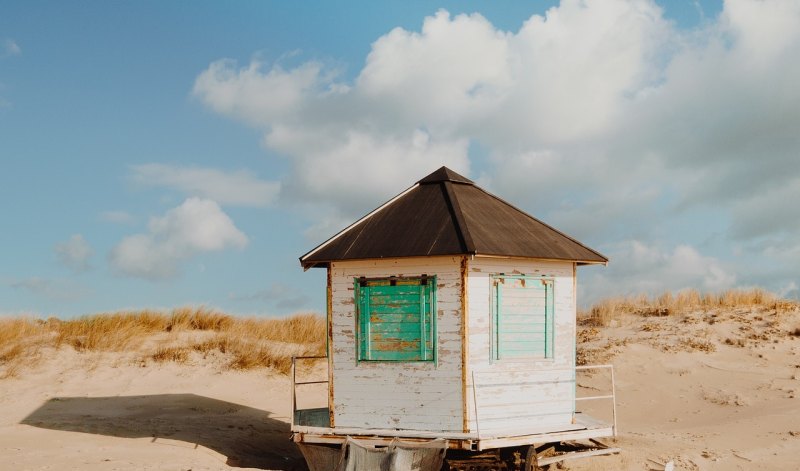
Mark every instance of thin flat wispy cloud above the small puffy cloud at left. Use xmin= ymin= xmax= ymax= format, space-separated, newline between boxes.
xmin=131 ymin=163 xmax=280 ymax=206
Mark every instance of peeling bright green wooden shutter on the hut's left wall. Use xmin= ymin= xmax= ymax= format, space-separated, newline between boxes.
xmin=356 ymin=278 xmax=436 ymax=361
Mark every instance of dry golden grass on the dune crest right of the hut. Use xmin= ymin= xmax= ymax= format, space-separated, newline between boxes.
xmin=577 ymin=288 xmax=800 ymax=365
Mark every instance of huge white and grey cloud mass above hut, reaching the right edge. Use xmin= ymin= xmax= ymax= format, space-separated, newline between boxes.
xmin=193 ymin=0 xmax=800 ymax=298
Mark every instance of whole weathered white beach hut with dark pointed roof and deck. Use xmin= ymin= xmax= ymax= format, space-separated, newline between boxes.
xmin=292 ymin=167 xmax=615 ymax=470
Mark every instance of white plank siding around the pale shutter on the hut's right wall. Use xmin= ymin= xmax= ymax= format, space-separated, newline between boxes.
xmin=467 ymin=257 xmax=575 ymax=434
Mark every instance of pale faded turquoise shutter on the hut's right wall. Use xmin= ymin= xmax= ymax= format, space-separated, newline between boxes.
xmin=492 ymin=275 xmax=553 ymax=360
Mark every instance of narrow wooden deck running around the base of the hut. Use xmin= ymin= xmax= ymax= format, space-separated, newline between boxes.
xmin=292 ymin=408 xmax=614 ymax=451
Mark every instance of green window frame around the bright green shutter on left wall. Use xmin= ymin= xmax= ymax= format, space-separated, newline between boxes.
xmin=353 ymin=274 xmax=438 ymax=364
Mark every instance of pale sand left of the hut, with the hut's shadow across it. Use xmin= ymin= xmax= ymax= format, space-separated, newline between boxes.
xmin=0 ymin=349 xmax=302 ymax=471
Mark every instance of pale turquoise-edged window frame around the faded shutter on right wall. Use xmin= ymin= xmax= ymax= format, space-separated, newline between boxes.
xmin=489 ymin=273 xmax=556 ymax=362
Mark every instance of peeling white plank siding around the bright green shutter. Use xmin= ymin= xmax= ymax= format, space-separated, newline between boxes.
xmin=331 ymin=257 xmax=463 ymax=432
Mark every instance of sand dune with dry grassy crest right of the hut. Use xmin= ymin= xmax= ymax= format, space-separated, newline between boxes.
xmin=570 ymin=302 xmax=800 ymax=470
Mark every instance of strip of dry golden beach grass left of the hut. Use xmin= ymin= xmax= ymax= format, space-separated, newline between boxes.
xmin=0 ymin=307 xmax=325 ymax=378
